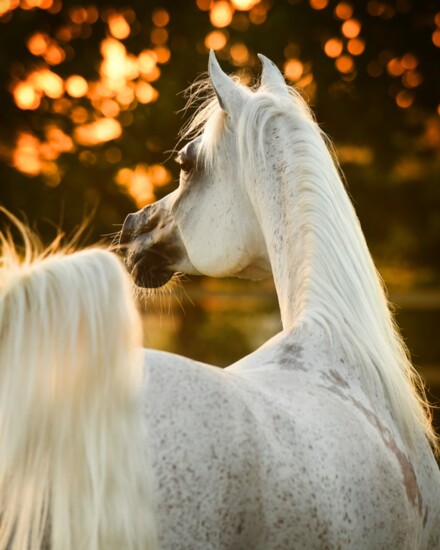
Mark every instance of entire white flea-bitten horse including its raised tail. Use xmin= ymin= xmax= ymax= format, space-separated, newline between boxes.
xmin=0 ymin=50 xmax=440 ymax=550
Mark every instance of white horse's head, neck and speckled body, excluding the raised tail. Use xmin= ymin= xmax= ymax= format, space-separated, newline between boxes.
xmin=117 ymin=52 xmax=440 ymax=550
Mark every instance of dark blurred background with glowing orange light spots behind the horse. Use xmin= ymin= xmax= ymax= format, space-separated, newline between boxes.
xmin=0 ymin=0 xmax=440 ymax=426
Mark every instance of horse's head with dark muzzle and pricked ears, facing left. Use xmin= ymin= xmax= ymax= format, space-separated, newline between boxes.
xmin=120 ymin=52 xmax=278 ymax=288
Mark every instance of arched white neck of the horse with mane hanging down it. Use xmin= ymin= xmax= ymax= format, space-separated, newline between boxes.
xmin=240 ymin=104 xmax=439 ymax=458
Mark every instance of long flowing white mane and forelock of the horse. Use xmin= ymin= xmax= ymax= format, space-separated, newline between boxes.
xmin=182 ymin=77 xmax=439 ymax=458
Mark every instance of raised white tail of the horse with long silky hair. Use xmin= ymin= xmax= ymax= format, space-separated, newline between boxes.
xmin=0 ymin=209 xmax=156 ymax=550
